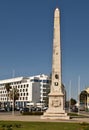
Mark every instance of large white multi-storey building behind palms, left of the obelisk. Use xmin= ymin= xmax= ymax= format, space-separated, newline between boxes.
xmin=0 ymin=75 xmax=49 ymax=107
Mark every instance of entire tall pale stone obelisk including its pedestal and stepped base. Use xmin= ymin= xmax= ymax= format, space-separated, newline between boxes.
xmin=42 ymin=8 xmax=69 ymax=119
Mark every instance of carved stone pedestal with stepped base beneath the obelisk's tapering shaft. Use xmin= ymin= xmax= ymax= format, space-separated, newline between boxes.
xmin=41 ymin=93 xmax=70 ymax=119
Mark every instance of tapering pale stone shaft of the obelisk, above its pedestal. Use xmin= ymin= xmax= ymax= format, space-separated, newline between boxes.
xmin=51 ymin=8 xmax=62 ymax=92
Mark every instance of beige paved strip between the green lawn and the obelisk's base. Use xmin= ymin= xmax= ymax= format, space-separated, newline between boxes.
xmin=0 ymin=114 xmax=89 ymax=123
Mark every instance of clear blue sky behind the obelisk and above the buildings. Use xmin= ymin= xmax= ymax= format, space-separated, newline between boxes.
xmin=0 ymin=0 xmax=89 ymax=97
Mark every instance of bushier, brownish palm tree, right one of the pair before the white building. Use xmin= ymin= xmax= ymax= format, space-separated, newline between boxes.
xmin=10 ymin=88 xmax=19 ymax=108
